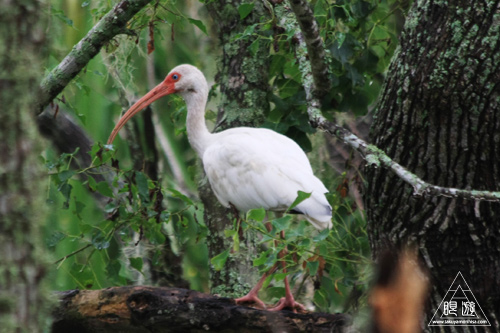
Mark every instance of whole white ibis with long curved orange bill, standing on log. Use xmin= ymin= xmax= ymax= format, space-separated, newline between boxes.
xmin=108 ymin=65 xmax=332 ymax=310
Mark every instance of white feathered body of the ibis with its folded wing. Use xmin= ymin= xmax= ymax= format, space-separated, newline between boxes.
xmin=203 ymin=127 xmax=331 ymax=220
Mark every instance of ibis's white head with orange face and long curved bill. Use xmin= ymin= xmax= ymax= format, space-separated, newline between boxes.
xmin=108 ymin=65 xmax=208 ymax=144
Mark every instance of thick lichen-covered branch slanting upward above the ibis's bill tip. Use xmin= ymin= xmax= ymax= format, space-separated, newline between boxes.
xmin=36 ymin=0 xmax=151 ymax=115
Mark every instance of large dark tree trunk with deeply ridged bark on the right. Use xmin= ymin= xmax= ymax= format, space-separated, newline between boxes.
xmin=365 ymin=0 xmax=500 ymax=332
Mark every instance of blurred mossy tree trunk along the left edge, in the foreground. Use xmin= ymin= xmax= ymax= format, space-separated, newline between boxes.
xmin=0 ymin=1 xmax=50 ymax=332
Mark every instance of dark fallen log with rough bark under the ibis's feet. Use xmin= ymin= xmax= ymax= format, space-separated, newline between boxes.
xmin=52 ymin=287 xmax=350 ymax=333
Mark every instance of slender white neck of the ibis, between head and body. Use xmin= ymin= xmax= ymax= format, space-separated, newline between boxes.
xmin=185 ymin=91 xmax=212 ymax=157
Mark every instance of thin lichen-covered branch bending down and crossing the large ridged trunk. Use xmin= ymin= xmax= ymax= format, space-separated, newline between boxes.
xmin=282 ymin=0 xmax=500 ymax=201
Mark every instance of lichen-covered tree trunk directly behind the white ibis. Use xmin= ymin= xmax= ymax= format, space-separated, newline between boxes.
xmin=200 ymin=1 xmax=269 ymax=297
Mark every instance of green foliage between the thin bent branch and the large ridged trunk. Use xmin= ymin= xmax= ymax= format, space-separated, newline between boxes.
xmin=314 ymin=0 xmax=401 ymax=115
